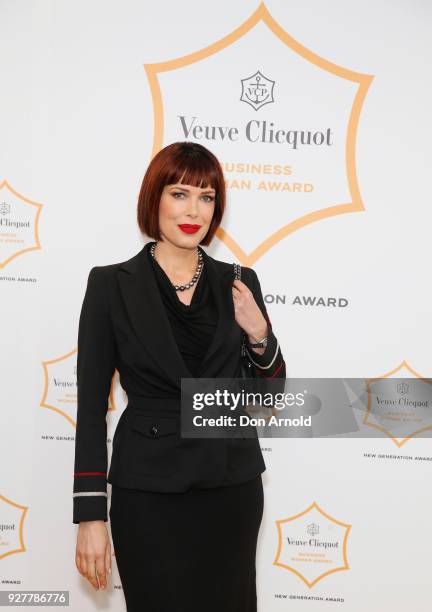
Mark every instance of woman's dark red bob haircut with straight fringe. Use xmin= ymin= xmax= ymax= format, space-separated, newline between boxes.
xmin=137 ymin=142 xmax=226 ymax=245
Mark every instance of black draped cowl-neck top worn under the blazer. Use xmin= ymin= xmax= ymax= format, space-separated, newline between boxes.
xmin=147 ymin=242 xmax=218 ymax=378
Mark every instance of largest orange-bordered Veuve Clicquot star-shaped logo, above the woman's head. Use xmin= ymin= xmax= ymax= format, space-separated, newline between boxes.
xmin=145 ymin=3 xmax=373 ymax=266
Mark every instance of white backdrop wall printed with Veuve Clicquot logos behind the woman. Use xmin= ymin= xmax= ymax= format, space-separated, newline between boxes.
xmin=0 ymin=0 xmax=432 ymax=612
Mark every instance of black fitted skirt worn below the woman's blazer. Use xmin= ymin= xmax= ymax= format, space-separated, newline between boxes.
xmin=109 ymin=474 xmax=264 ymax=612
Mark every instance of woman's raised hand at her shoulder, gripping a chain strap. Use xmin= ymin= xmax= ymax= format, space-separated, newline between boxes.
xmin=232 ymin=279 xmax=268 ymax=350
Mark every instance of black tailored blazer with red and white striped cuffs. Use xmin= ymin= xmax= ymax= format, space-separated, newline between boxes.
xmin=73 ymin=245 xmax=286 ymax=523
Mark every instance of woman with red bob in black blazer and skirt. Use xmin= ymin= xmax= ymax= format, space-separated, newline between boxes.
xmin=73 ymin=142 xmax=285 ymax=612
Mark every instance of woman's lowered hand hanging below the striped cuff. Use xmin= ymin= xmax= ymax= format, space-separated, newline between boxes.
xmin=75 ymin=520 xmax=111 ymax=590
